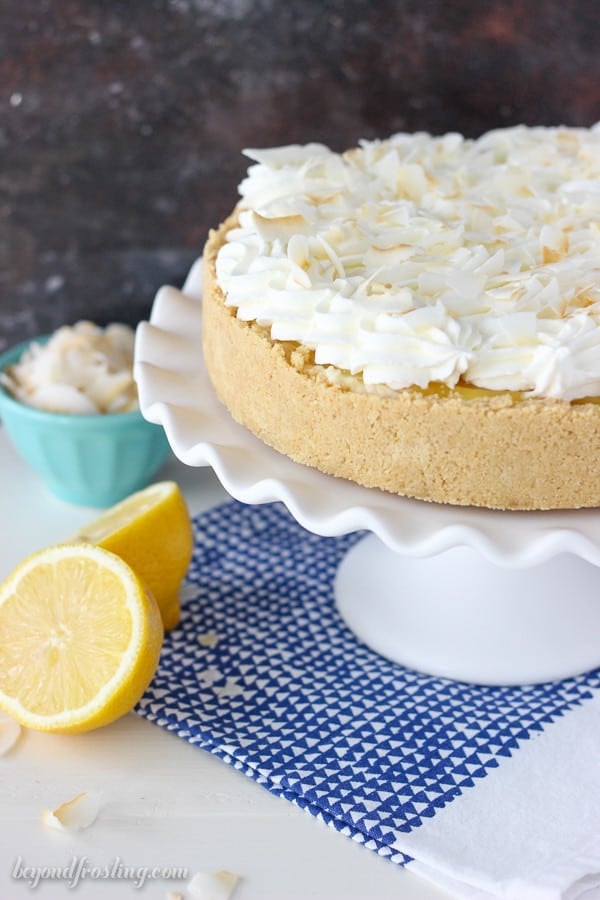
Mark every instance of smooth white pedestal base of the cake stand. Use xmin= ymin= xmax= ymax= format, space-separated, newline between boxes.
xmin=335 ymin=535 xmax=600 ymax=685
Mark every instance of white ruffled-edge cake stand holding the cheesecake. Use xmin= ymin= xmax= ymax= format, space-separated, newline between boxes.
xmin=135 ymin=261 xmax=600 ymax=685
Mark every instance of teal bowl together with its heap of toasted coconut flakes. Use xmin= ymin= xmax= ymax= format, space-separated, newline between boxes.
xmin=0 ymin=321 xmax=170 ymax=507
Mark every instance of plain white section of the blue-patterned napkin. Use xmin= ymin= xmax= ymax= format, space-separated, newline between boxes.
xmin=394 ymin=693 xmax=600 ymax=900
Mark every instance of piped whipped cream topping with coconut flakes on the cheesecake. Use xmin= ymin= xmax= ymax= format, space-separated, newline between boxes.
xmin=217 ymin=123 xmax=600 ymax=400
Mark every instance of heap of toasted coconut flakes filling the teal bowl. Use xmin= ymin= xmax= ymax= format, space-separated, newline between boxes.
xmin=0 ymin=321 xmax=139 ymax=415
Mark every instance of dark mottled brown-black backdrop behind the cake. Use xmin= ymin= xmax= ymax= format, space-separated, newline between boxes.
xmin=0 ymin=0 xmax=600 ymax=350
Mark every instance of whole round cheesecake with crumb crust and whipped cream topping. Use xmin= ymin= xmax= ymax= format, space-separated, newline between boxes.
xmin=203 ymin=126 xmax=600 ymax=509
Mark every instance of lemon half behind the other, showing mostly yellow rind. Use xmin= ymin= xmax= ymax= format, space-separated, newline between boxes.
xmin=73 ymin=481 xmax=194 ymax=631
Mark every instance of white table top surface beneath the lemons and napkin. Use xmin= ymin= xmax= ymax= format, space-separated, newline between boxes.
xmin=0 ymin=427 xmax=447 ymax=900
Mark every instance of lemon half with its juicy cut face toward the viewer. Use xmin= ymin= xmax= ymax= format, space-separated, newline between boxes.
xmin=0 ymin=544 xmax=163 ymax=733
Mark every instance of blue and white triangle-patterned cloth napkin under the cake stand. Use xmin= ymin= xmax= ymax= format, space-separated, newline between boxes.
xmin=138 ymin=501 xmax=600 ymax=900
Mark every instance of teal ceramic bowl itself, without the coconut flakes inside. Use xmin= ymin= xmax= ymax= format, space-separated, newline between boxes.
xmin=0 ymin=338 xmax=170 ymax=507
